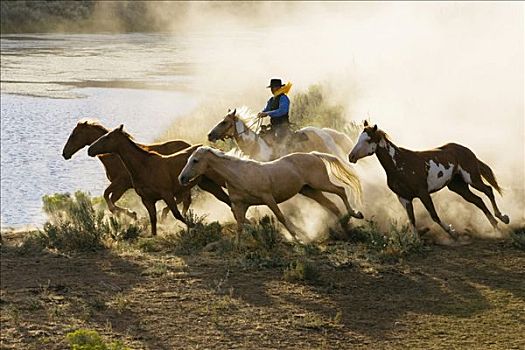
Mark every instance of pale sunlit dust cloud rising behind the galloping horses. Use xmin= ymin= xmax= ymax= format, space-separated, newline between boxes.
xmin=119 ymin=2 xmax=525 ymax=241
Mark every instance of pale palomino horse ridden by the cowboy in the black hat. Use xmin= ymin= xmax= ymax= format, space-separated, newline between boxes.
xmin=208 ymin=109 xmax=353 ymax=162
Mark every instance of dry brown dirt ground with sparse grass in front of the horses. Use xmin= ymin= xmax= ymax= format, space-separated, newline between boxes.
xmin=0 ymin=234 xmax=525 ymax=349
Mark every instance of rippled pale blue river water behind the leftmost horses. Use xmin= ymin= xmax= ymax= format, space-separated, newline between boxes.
xmin=0 ymin=34 xmax=204 ymax=228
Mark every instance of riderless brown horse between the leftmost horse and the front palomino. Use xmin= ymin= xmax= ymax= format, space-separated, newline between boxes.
xmin=88 ymin=125 xmax=231 ymax=235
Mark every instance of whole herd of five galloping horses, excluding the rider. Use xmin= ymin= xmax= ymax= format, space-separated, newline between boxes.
xmin=62 ymin=110 xmax=510 ymax=244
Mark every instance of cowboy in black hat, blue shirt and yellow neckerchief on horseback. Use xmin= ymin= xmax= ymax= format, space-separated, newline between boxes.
xmin=257 ymin=79 xmax=292 ymax=139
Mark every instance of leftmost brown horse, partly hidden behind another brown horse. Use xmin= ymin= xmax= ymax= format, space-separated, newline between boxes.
xmin=62 ymin=121 xmax=191 ymax=219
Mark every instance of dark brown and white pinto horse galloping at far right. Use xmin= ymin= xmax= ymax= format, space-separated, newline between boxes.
xmin=348 ymin=121 xmax=510 ymax=238
